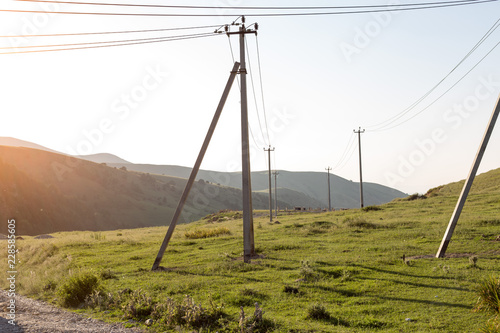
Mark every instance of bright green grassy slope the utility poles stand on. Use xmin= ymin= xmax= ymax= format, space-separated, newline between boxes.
xmin=0 ymin=169 xmax=500 ymax=333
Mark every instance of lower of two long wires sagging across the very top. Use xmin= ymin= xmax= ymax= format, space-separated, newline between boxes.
xmin=0 ymin=0 xmax=499 ymax=17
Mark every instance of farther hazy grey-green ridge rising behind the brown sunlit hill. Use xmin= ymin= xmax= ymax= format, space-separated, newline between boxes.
xmin=110 ymin=163 xmax=406 ymax=208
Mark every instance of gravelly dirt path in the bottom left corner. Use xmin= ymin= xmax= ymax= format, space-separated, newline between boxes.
xmin=0 ymin=290 xmax=144 ymax=333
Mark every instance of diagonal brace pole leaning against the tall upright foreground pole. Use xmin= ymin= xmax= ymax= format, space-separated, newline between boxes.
xmin=151 ymin=62 xmax=240 ymax=271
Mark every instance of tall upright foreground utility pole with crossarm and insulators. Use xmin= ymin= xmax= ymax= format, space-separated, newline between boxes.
xmin=227 ymin=16 xmax=258 ymax=263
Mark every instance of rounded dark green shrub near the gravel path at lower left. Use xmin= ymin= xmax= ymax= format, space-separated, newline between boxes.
xmin=57 ymin=272 xmax=99 ymax=307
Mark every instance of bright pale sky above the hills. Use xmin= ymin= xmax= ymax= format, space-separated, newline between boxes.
xmin=0 ymin=0 xmax=500 ymax=193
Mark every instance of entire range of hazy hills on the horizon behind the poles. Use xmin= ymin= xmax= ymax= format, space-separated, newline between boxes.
xmin=0 ymin=138 xmax=406 ymax=235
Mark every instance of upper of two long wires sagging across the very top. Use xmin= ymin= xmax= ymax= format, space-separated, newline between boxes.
xmin=16 ymin=0 xmax=494 ymax=10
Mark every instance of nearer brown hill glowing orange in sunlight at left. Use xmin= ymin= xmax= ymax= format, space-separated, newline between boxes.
xmin=0 ymin=146 xmax=286 ymax=235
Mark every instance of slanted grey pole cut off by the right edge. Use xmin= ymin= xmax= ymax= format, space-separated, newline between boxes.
xmin=436 ymin=92 xmax=500 ymax=258
